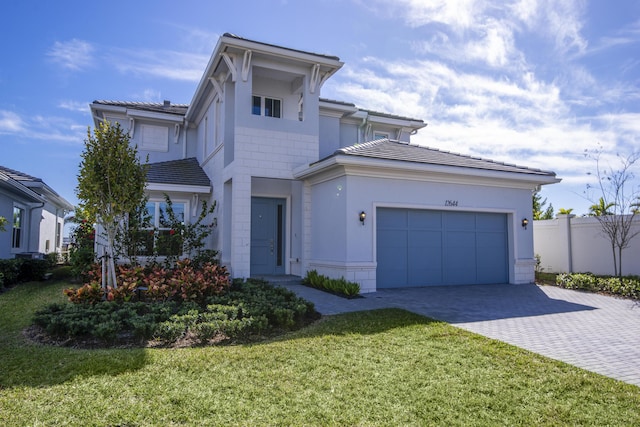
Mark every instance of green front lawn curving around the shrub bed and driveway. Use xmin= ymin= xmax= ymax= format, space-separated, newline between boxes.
xmin=0 ymin=282 xmax=640 ymax=426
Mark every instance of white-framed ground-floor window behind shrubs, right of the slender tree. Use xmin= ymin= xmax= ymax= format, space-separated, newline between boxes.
xmin=141 ymin=201 xmax=187 ymax=256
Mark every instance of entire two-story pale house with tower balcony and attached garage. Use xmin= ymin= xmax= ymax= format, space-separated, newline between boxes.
xmin=91 ymin=34 xmax=559 ymax=292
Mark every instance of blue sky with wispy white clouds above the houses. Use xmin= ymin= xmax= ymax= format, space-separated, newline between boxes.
xmin=0 ymin=0 xmax=640 ymax=214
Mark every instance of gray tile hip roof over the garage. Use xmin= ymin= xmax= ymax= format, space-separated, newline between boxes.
xmin=334 ymin=138 xmax=555 ymax=176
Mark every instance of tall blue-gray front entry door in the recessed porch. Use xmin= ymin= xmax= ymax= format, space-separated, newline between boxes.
xmin=251 ymin=197 xmax=285 ymax=276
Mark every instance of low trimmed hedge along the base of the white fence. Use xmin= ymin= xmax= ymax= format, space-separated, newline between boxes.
xmin=556 ymin=273 xmax=640 ymax=299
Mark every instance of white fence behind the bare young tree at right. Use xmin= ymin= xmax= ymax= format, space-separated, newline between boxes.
xmin=533 ymin=215 xmax=640 ymax=275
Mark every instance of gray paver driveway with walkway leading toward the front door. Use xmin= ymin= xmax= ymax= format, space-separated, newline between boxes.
xmin=285 ymin=284 xmax=640 ymax=386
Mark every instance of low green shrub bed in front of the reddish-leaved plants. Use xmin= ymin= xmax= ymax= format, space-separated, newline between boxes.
xmin=34 ymin=278 xmax=318 ymax=345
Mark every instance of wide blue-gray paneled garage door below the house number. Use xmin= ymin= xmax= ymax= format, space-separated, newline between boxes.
xmin=377 ymin=208 xmax=509 ymax=288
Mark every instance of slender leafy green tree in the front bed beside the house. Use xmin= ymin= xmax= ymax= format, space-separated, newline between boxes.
xmin=76 ymin=121 xmax=146 ymax=289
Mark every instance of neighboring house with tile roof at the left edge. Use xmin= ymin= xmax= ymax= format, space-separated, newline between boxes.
xmin=0 ymin=166 xmax=73 ymax=259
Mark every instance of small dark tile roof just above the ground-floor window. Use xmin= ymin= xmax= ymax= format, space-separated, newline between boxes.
xmin=147 ymin=157 xmax=211 ymax=187
